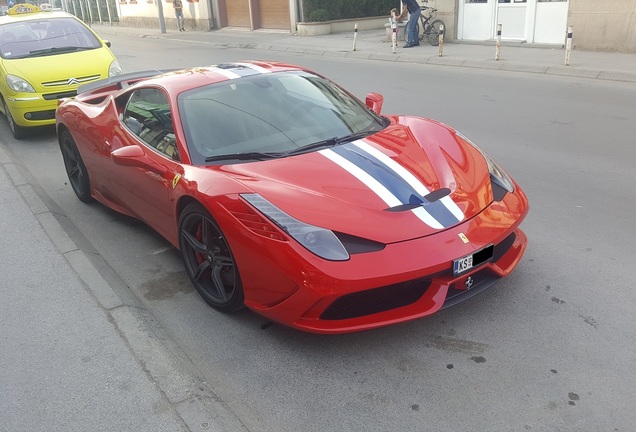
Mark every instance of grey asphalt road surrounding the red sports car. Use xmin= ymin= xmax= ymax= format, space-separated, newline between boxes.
xmin=0 ymin=36 xmax=636 ymax=432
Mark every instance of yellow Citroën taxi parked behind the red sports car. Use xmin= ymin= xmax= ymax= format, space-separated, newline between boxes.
xmin=0 ymin=4 xmax=122 ymax=139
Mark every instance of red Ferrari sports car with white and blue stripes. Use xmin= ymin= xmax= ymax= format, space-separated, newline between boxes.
xmin=56 ymin=61 xmax=528 ymax=333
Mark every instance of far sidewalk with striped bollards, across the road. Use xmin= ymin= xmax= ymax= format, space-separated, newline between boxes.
xmin=92 ymin=24 xmax=636 ymax=82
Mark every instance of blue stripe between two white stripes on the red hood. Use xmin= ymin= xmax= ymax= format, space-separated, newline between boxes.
xmin=331 ymin=144 xmax=459 ymax=228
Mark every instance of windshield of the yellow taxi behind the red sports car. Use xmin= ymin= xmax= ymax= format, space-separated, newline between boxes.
xmin=0 ymin=18 xmax=101 ymax=59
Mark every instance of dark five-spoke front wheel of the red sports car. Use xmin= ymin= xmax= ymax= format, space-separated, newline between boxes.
xmin=179 ymin=203 xmax=244 ymax=312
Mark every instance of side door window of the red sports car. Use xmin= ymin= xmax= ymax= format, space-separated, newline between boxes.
xmin=122 ymin=88 xmax=179 ymax=160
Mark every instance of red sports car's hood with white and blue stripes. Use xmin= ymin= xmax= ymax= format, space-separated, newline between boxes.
xmin=220 ymin=117 xmax=492 ymax=243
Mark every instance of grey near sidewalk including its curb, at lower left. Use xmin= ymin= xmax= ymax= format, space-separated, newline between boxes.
xmin=0 ymin=145 xmax=246 ymax=432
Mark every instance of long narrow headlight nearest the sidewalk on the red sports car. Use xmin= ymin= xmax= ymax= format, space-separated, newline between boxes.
xmin=241 ymin=194 xmax=349 ymax=261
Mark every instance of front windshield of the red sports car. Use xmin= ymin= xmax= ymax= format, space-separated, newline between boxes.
xmin=179 ymin=71 xmax=386 ymax=164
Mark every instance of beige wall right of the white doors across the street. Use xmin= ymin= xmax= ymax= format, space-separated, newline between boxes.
xmin=568 ymin=0 xmax=636 ymax=53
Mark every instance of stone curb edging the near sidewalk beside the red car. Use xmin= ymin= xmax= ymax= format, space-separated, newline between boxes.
xmin=0 ymin=145 xmax=248 ymax=432
